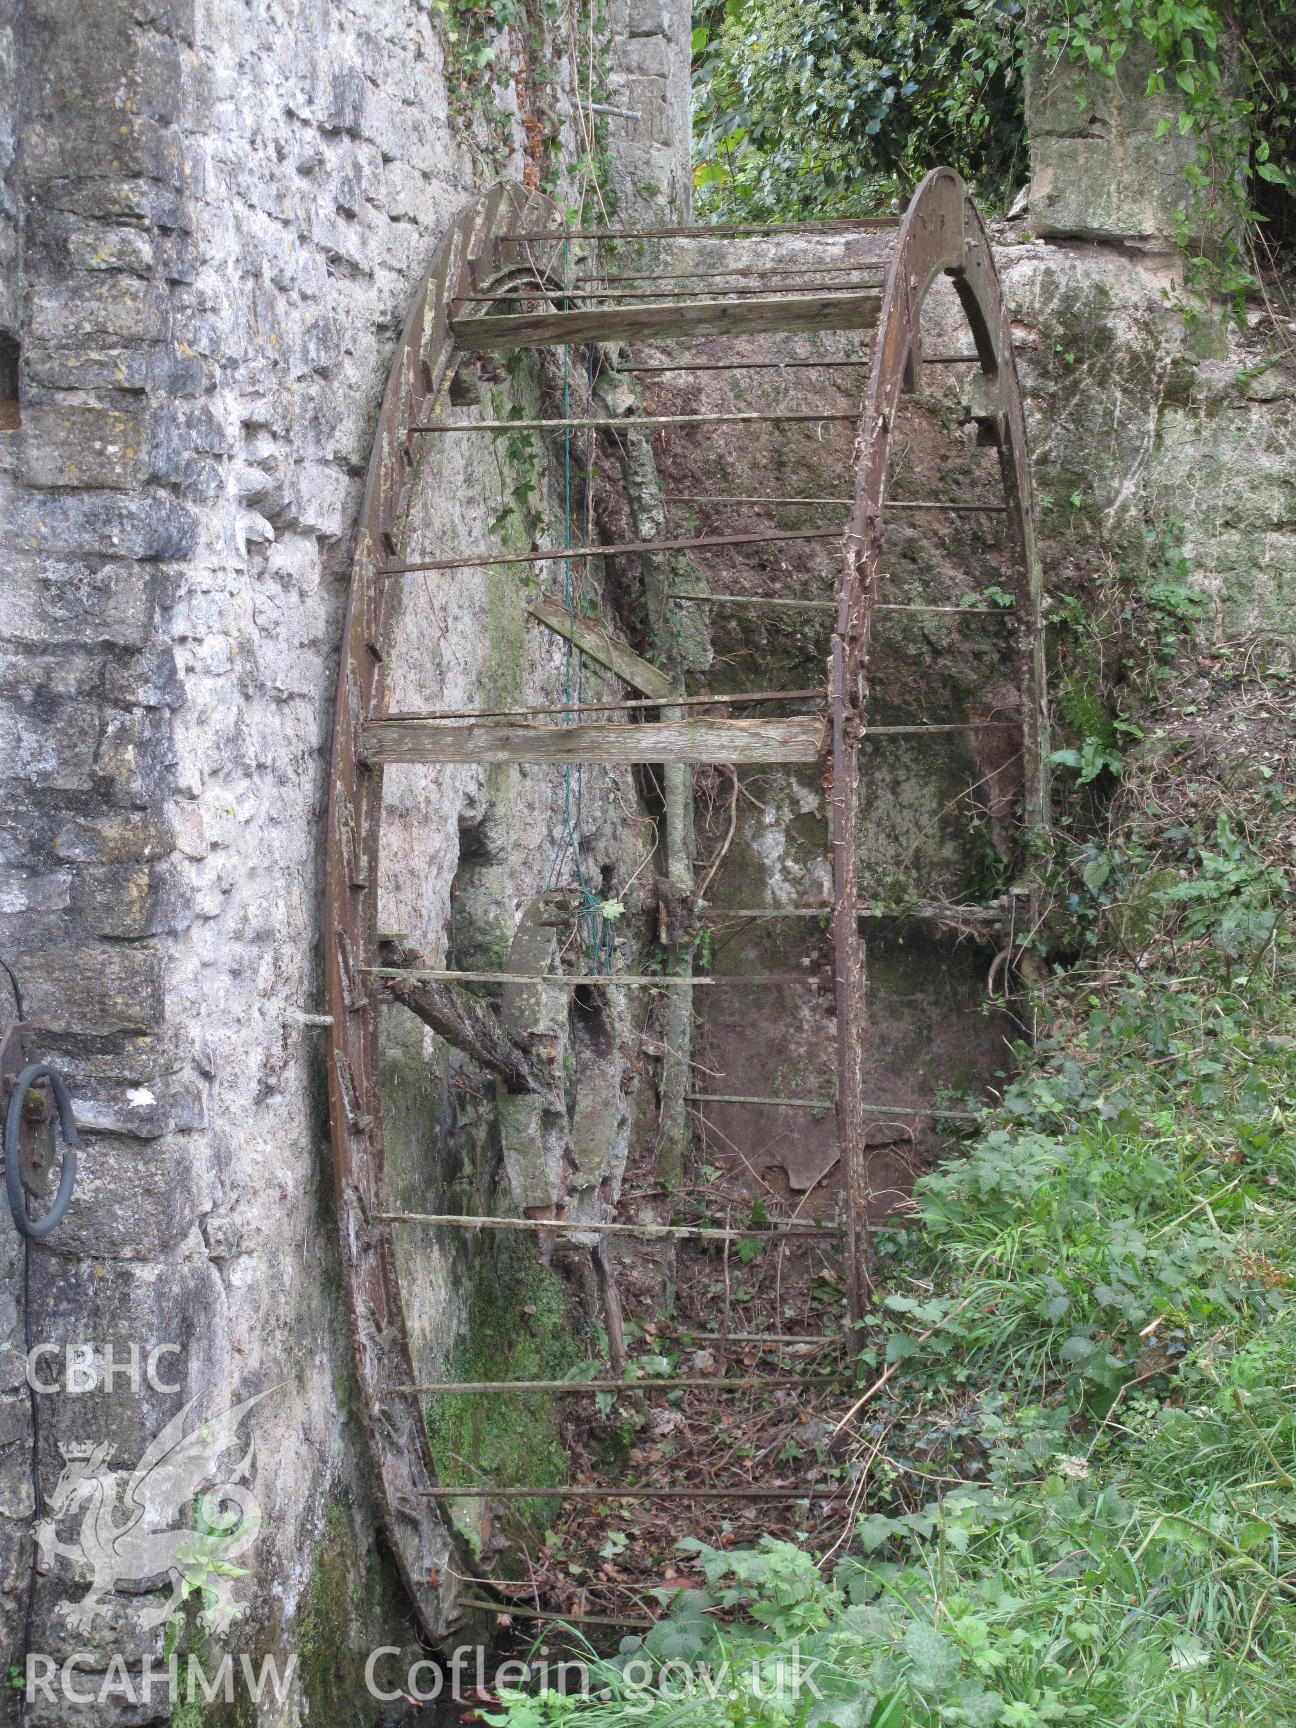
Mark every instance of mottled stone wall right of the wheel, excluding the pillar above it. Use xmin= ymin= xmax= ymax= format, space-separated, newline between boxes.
xmin=997 ymin=235 xmax=1296 ymax=642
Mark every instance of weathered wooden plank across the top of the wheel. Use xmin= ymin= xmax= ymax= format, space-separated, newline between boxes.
xmin=449 ymin=292 xmax=881 ymax=351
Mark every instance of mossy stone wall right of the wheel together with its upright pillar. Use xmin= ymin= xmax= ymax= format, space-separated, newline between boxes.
xmin=1022 ymin=5 xmax=1296 ymax=653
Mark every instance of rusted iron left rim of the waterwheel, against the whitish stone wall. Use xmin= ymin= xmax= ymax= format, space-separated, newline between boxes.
xmin=323 ymin=185 xmax=562 ymax=1640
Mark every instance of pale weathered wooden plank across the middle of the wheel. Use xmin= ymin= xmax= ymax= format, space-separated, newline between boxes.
xmin=361 ymin=719 xmax=824 ymax=764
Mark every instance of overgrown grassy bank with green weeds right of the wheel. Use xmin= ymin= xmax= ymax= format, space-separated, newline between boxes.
xmin=492 ymin=577 xmax=1296 ymax=1728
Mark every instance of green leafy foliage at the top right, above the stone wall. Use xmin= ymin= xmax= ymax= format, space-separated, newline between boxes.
xmin=693 ymin=0 xmax=1296 ymax=318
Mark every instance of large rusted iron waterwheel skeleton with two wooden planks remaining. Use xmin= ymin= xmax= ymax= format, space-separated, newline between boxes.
xmin=325 ymin=169 xmax=1044 ymax=1643
